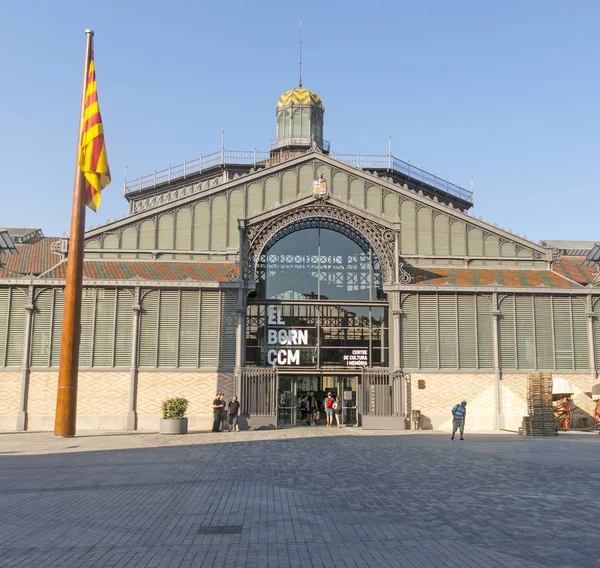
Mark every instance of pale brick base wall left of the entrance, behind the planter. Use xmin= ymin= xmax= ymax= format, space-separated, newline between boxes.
xmin=0 ymin=370 xmax=234 ymax=431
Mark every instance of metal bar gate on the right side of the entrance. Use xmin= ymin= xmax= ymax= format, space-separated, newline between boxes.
xmin=361 ymin=368 xmax=410 ymax=430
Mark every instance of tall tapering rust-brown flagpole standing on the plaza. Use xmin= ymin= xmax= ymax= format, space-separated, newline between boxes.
xmin=54 ymin=30 xmax=94 ymax=437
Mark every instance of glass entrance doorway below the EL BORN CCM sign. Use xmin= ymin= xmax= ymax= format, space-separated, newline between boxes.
xmin=277 ymin=374 xmax=359 ymax=428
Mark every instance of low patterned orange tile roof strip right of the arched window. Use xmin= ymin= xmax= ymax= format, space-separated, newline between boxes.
xmin=405 ymin=266 xmax=579 ymax=288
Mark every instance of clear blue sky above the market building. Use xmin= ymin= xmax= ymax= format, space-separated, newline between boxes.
xmin=0 ymin=0 xmax=600 ymax=242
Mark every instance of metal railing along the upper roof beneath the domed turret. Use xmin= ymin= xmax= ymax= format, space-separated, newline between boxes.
xmin=124 ymin=150 xmax=473 ymax=202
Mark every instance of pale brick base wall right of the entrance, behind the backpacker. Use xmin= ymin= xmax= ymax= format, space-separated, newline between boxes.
xmin=411 ymin=372 xmax=598 ymax=432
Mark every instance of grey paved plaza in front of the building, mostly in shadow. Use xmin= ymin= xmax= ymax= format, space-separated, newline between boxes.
xmin=0 ymin=428 xmax=600 ymax=568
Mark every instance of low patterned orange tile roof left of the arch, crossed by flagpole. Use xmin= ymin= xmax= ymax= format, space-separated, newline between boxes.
xmin=40 ymin=260 xmax=238 ymax=282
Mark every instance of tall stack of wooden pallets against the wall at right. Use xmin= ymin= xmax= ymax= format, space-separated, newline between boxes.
xmin=519 ymin=373 xmax=558 ymax=436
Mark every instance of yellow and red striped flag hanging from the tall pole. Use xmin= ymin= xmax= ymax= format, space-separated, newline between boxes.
xmin=79 ymin=50 xmax=110 ymax=211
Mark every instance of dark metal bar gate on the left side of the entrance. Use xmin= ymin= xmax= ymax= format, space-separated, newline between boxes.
xmin=236 ymin=367 xmax=277 ymax=430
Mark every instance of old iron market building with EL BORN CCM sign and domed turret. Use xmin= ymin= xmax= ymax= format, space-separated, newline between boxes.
xmin=0 ymin=88 xmax=600 ymax=430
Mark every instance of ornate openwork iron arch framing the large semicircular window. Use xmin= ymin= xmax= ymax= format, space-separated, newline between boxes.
xmin=245 ymin=203 xmax=394 ymax=284
